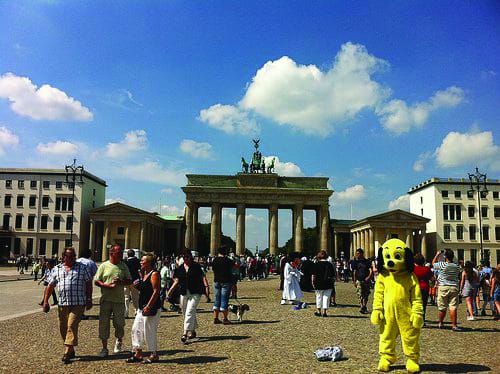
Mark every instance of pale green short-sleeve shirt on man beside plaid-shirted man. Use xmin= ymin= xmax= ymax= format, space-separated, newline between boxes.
xmin=94 ymin=260 xmax=132 ymax=303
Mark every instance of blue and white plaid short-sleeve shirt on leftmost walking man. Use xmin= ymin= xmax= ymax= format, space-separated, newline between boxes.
xmin=50 ymin=262 xmax=92 ymax=306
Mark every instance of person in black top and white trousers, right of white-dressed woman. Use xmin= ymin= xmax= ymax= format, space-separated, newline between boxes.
xmin=311 ymin=251 xmax=335 ymax=317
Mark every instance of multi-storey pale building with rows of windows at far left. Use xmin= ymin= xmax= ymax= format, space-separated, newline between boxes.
xmin=0 ymin=168 xmax=106 ymax=258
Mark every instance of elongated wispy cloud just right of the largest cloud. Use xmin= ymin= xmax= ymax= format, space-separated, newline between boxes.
xmin=376 ymin=86 xmax=465 ymax=135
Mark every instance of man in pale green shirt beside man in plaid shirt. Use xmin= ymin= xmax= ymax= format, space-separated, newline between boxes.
xmin=94 ymin=245 xmax=132 ymax=357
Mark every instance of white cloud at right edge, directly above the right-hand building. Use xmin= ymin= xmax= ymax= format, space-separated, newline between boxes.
xmin=435 ymin=131 xmax=500 ymax=171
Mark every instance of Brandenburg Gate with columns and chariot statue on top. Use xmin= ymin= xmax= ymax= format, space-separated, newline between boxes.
xmin=182 ymin=140 xmax=333 ymax=255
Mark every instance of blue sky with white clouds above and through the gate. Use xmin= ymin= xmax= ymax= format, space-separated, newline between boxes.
xmin=0 ymin=1 xmax=500 ymax=248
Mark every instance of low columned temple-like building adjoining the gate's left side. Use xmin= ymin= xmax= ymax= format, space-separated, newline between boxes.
xmin=89 ymin=202 xmax=184 ymax=261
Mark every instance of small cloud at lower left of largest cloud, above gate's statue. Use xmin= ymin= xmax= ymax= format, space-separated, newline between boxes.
xmin=198 ymin=104 xmax=260 ymax=136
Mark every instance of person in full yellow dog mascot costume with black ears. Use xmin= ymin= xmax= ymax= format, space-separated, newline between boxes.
xmin=371 ymin=239 xmax=424 ymax=373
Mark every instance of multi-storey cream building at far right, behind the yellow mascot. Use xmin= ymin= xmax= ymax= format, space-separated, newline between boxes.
xmin=408 ymin=178 xmax=500 ymax=265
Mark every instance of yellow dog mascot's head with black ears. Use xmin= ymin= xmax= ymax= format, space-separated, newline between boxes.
xmin=377 ymin=239 xmax=414 ymax=273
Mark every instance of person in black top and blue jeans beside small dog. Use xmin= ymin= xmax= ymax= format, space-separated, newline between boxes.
xmin=212 ymin=247 xmax=234 ymax=325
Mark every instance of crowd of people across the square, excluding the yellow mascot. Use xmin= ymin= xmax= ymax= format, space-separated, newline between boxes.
xmin=38 ymin=245 xmax=500 ymax=364
